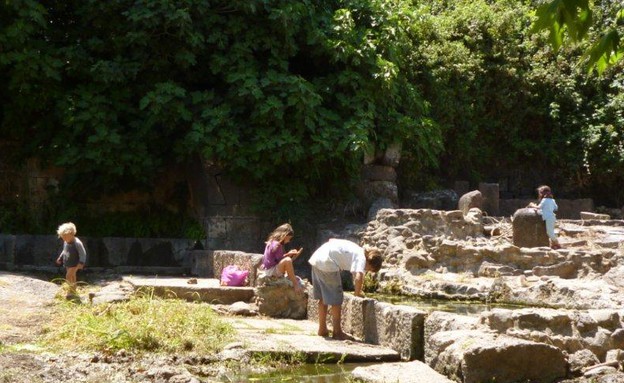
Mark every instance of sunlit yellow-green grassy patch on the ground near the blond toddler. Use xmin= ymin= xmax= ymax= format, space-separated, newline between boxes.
xmin=44 ymin=294 xmax=234 ymax=353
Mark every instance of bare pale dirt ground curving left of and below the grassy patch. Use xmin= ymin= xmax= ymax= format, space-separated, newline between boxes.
xmin=0 ymin=272 xmax=224 ymax=383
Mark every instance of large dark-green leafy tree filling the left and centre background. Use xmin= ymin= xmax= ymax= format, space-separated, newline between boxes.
xmin=0 ymin=0 xmax=440 ymax=213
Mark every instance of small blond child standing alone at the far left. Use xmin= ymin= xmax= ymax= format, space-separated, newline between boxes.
xmin=56 ymin=222 xmax=87 ymax=296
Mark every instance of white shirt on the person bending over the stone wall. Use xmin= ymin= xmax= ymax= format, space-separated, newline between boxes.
xmin=308 ymin=239 xmax=366 ymax=273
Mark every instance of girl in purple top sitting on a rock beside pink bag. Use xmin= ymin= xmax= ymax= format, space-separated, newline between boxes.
xmin=262 ymin=223 xmax=303 ymax=293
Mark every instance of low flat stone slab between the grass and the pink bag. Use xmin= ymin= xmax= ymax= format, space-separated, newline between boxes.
xmin=123 ymin=276 xmax=254 ymax=305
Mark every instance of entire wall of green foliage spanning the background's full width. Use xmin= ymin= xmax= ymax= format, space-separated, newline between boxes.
xmin=0 ymin=0 xmax=624 ymax=231
